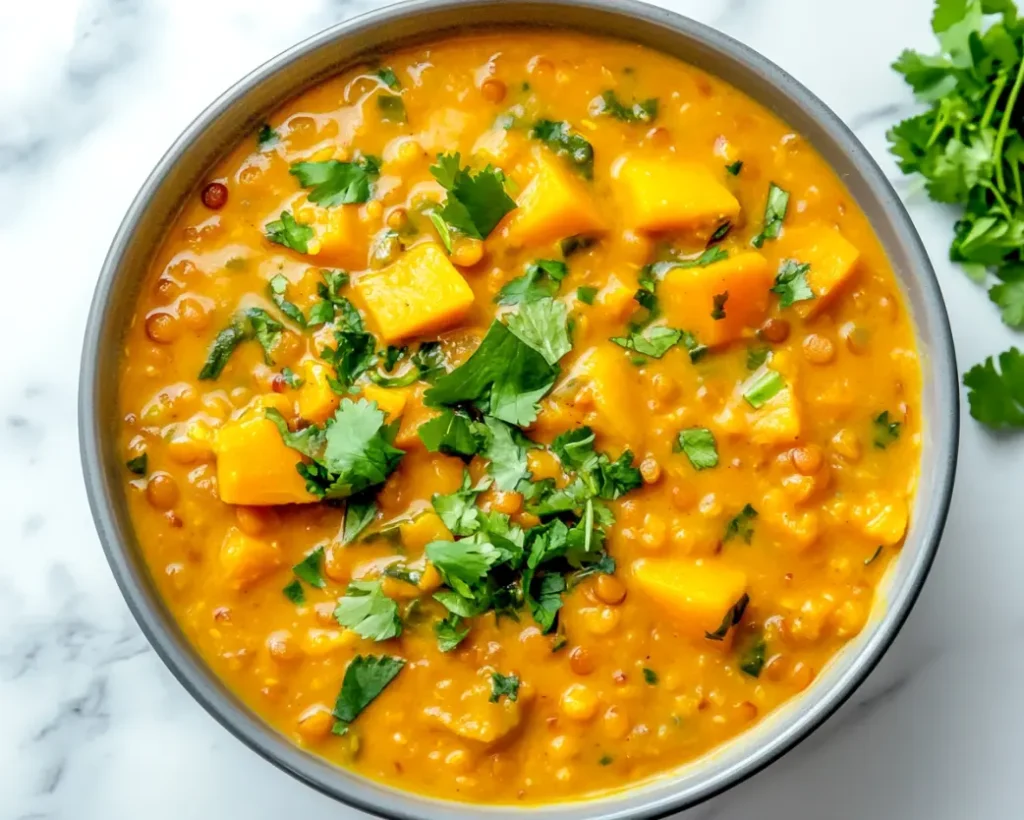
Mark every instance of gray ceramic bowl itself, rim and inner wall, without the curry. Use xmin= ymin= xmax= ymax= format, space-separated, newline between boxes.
xmin=79 ymin=0 xmax=959 ymax=820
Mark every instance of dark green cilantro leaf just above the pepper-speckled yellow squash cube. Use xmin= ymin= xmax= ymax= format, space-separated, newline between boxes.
xmin=430 ymin=154 xmax=516 ymax=240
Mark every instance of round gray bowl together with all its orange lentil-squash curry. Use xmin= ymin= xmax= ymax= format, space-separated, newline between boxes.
xmin=81 ymin=0 xmax=958 ymax=818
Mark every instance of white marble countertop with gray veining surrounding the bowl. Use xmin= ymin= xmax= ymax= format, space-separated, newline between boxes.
xmin=0 ymin=0 xmax=1024 ymax=820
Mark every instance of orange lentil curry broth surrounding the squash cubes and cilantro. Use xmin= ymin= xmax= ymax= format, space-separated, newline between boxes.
xmin=120 ymin=31 xmax=921 ymax=803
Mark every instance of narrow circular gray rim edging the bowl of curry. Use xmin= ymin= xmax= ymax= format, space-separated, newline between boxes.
xmin=78 ymin=0 xmax=959 ymax=820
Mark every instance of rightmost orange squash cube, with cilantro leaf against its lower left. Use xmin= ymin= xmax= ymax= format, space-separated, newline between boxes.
xmin=771 ymin=225 xmax=860 ymax=318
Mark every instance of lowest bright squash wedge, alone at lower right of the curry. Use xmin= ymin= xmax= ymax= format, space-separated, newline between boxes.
xmin=632 ymin=558 xmax=746 ymax=640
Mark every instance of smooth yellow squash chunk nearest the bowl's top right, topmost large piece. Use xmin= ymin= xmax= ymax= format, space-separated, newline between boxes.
xmin=613 ymin=156 xmax=739 ymax=232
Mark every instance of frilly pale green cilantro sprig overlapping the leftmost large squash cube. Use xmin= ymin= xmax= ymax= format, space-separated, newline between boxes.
xmin=264 ymin=398 xmax=406 ymax=499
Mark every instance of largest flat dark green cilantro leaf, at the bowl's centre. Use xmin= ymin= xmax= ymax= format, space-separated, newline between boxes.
xmin=424 ymin=320 xmax=558 ymax=427
